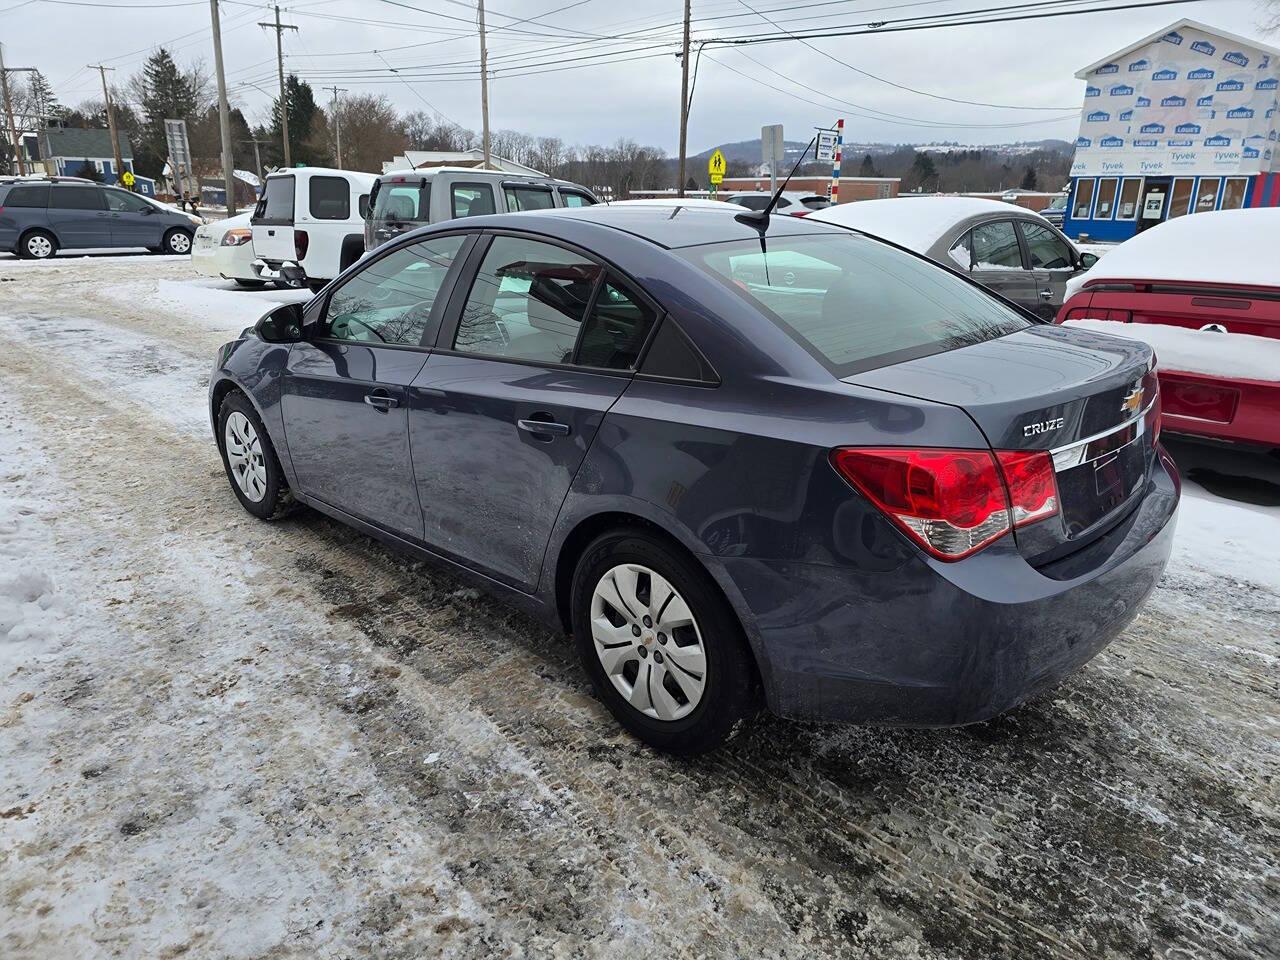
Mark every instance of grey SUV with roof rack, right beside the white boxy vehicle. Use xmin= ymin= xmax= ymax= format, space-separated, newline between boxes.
xmin=365 ymin=166 xmax=599 ymax=250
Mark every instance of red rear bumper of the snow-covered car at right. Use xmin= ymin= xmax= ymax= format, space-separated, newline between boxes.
xmin=1160 ymin=370 xmax=1280 ymax=447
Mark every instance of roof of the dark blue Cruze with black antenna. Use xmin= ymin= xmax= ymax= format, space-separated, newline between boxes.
xmin=494 ymin=200 xmax=838 ymax=250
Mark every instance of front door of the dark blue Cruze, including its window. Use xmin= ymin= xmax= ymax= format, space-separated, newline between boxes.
xmin=280 ymin=234 xmax=467 ymax=539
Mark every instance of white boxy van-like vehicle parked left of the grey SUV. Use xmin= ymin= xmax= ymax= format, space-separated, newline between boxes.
xmin=250 ymin=166 xmax=378 ymax=289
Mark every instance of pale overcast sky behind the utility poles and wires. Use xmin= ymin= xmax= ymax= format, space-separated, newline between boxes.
xmin=0 ymin=0 xmax=1280 ymax=154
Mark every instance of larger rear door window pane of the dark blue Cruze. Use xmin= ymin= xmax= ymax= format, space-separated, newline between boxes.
xmin=453 ymin=237 xmax=602 ymax=364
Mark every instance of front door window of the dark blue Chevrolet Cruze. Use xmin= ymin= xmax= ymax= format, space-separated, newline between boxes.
xmin=325 ymin=234 xmax=465 ymax=346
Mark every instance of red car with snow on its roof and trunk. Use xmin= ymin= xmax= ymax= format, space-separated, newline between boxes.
xmin=1059 ymin=207 xmax=1280 ymax=448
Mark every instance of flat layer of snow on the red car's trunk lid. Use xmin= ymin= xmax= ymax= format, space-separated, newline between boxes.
xmin=1064 ymin=319 xmax=1280 ymax=380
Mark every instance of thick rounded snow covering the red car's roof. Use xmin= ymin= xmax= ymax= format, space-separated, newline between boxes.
xmin=1068 ymin=207 xmax=1280 ymax=294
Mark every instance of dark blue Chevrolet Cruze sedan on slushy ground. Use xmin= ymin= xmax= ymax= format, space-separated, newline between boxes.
xmin=210 ymin=205 xmax=1179 ymax=754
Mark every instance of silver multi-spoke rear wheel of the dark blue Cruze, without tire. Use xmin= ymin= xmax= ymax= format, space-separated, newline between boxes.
xmin=590 ymin=563 xmax=707 ymax=721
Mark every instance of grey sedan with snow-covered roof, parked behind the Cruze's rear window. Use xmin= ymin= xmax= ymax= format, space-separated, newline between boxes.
xmin=810 ymin=197 xmax=1097 ymax=320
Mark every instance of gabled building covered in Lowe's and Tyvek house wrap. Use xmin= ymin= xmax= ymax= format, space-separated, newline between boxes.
xmin=1062 ymin=19 xmax=1280 ymax=241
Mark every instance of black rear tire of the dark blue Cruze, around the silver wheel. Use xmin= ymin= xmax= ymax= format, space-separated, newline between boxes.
xmin=571 ymin=529 xmax=759 ymax=756
